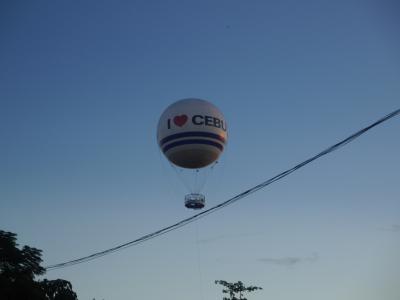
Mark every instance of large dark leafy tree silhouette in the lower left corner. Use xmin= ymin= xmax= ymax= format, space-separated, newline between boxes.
xmin=0 ymin=230 xmax=78 ymax=300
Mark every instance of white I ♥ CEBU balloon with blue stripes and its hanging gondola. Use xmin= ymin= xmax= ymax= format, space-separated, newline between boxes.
xmin=157 ymin=98 xmax=228 ymax=209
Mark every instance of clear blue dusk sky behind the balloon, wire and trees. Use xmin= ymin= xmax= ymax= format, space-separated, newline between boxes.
xmin=0 ymin=0 xmax=400 ymax=300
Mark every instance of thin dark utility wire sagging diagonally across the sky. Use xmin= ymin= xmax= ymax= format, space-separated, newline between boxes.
xmin=45 ymin=109 xmax=400 ymax=271
